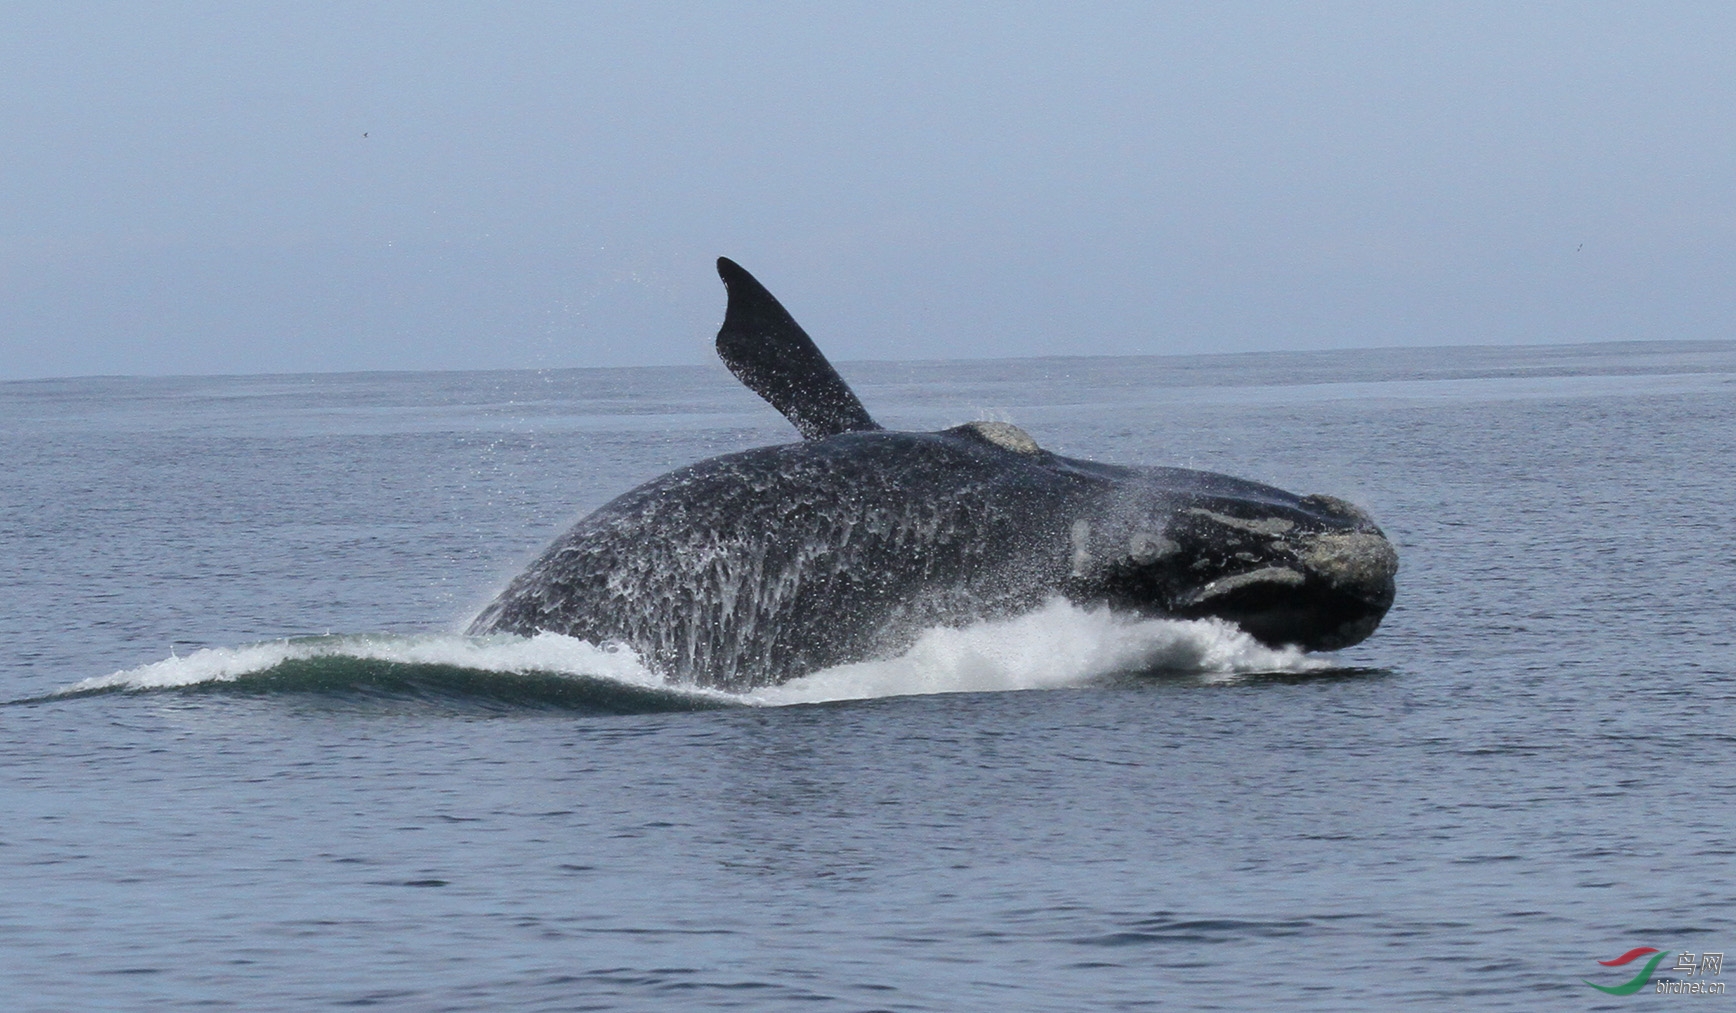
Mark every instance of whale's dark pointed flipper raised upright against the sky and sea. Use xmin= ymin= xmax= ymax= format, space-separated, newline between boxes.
xmin=717 ymin=257 xmax=880 ymax=439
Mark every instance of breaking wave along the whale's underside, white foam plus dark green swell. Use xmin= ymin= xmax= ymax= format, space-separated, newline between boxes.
xmin=43 ymin=600 xmax=1328 ymax=713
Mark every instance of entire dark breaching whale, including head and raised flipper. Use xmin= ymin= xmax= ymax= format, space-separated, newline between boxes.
xmin=469 ymin=258 xmax=1397 ymax=690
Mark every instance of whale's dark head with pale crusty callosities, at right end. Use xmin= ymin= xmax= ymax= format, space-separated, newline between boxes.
xmin=1071 ymin=468 xmax=1399 ymax=650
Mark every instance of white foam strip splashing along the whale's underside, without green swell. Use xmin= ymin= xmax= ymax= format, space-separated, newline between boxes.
xmin=61 ymin=600 xmax=1326 ymax=706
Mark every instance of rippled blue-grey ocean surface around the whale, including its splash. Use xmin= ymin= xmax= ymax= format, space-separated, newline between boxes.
xmin=0 ymin=342 xmax=1736 ymax=1011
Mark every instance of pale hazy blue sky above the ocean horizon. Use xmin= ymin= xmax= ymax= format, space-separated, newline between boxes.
xmin=0 ymin=0 xmax=1736 ymax=380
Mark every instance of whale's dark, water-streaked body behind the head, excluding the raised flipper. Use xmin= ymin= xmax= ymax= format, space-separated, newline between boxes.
xmin=470 ymin=432 xmax=1087 ymax=689
